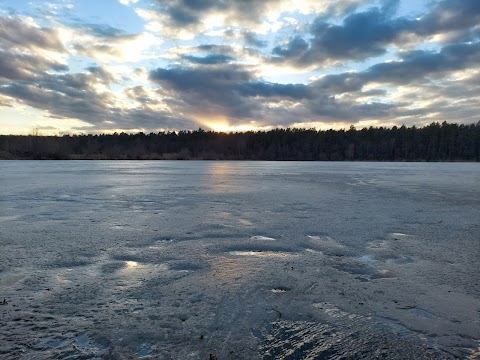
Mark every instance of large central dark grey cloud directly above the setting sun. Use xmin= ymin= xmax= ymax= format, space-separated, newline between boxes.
xmin=150 ymin=65 xmax=404 ymax=126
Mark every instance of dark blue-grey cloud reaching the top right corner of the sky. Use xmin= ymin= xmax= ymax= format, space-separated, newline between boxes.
xmin=272 ymin=0 xmax=480 ymax=67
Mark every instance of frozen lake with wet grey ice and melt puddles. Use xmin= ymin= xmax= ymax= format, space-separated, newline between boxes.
xmin=0 ymin=161 xmax=480 ymax=360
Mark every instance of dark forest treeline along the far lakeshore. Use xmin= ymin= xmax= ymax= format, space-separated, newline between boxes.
xmin=0 ymin=121 xmax=480 ymax=162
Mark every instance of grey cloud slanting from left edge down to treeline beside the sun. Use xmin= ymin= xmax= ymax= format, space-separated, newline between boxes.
xmin=0 ymin=72 xmax=195 ymax=131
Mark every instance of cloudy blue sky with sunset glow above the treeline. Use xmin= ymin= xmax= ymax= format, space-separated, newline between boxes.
xmin=0 ymin=0 xmax=480 ymax=135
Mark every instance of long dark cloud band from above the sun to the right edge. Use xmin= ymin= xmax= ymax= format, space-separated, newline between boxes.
xmin=150 ymin=37 xmax=480 ymax=126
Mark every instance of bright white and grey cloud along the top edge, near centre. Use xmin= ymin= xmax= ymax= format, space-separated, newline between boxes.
xmin=136 ymin=0 xmax=370 ymax=39
